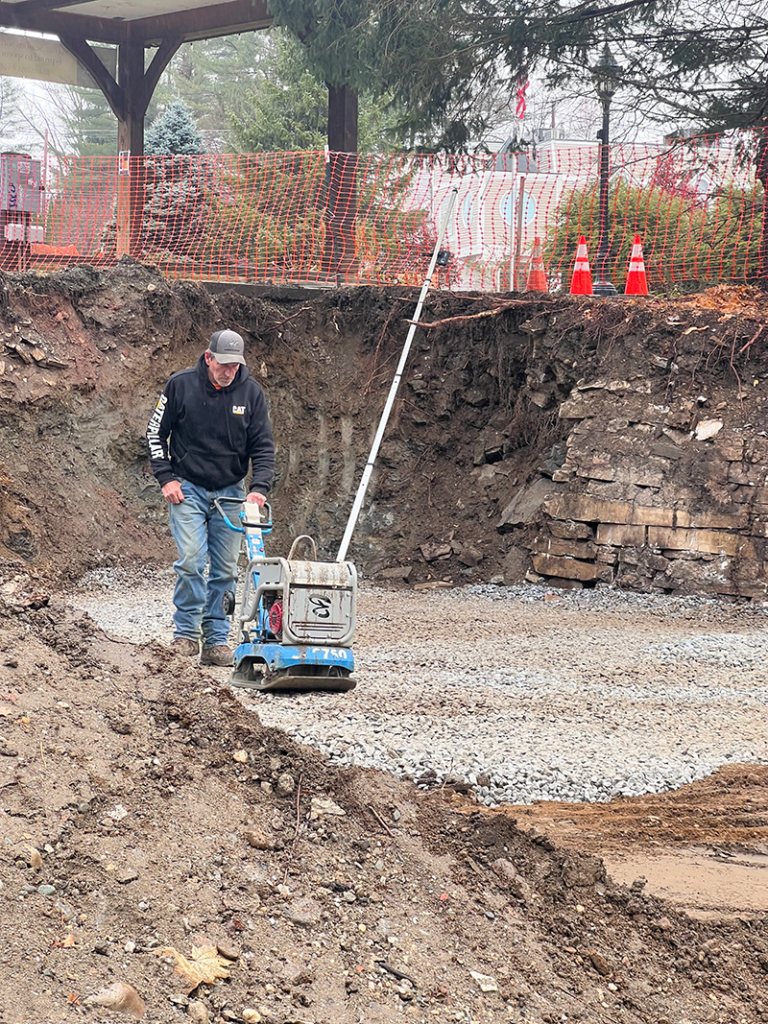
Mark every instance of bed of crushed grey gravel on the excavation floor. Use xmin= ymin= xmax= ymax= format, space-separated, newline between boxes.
xmin=70 ymin=569 xmax=768 ymax=806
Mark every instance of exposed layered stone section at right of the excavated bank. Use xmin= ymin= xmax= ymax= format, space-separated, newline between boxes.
xmin=499 ymin=380 xmax=768 ymax=598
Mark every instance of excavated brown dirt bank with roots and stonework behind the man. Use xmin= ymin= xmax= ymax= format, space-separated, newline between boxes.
xmin=0 ymin=261 xmax=768 ymax=597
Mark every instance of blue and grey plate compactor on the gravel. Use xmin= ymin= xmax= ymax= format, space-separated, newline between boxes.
xmin=216 ymin=499 xmax=357 ymax=692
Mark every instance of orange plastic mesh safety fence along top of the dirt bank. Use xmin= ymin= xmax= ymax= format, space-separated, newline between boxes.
xmin=7 ymin=132 xmax=768 ymax=292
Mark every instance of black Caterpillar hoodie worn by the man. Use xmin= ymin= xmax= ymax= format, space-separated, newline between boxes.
xmin=146 ymin=355 xmax=274 ymax=494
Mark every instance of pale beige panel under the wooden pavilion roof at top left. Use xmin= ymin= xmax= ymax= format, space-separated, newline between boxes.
xmin=0 ymin=32 xmax=118 ymax=89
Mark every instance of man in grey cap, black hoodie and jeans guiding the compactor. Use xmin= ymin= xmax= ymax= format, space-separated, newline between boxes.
xmin=146 ymin=331 xmax=274 ymax=666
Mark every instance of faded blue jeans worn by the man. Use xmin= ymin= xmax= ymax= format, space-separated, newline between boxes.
xmin=168 ymin=480 xmax=246 ymax=647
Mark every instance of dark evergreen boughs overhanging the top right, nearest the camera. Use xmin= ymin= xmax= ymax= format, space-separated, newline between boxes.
xmin=270 ymin=0 xmax=768 ymax=278
